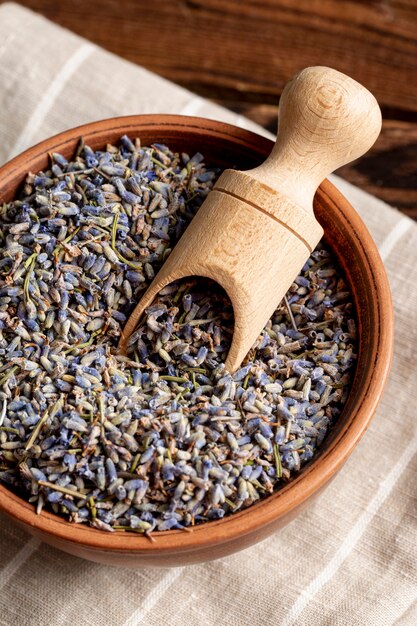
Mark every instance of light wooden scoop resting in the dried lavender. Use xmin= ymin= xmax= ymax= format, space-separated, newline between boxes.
xmin=119 ymin=67 xmax=381 ymax=372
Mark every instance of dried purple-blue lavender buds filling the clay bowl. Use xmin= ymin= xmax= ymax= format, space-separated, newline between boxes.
xmin=0 ymin=137 xmax=356 ymax=535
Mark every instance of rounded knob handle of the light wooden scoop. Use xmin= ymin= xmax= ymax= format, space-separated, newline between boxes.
xmin=247 ymin=66 xmax=382 ymax=211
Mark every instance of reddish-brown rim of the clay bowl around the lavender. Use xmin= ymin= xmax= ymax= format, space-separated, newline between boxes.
xmin=0 ymin=114 xmax=394 ymax=556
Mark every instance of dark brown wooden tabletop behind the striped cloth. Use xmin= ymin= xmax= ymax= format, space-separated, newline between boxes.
xmin=4 ymin=0 xmax=417 ymax=219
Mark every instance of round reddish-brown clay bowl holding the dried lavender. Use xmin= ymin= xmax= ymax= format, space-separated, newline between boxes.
xmin=0 ymin=115 xmax=393 ymax=567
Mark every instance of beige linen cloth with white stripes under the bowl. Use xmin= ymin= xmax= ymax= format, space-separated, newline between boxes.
xmin=0 ymin=4 xmax=417 ymax=626
